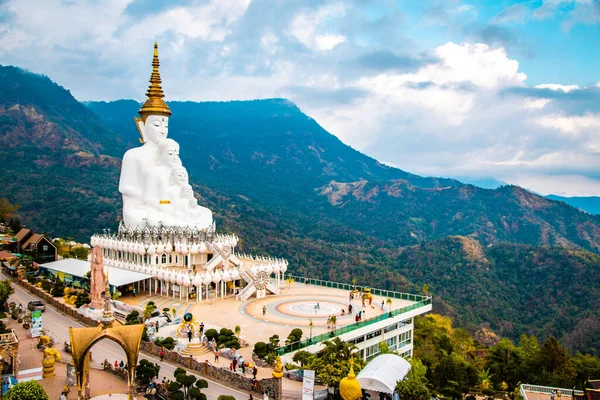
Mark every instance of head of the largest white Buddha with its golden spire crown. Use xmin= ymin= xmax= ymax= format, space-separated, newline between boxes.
xmin=136 ymin=43 xmax=171 ymax=144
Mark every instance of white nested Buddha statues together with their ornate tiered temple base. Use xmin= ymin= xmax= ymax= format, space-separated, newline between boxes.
xmin=91 ymin=44 xmax=288 ymax=302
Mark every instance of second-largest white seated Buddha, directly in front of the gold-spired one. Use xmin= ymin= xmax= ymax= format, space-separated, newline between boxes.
xmin=143 ymin=139 xmax=187 ymax=226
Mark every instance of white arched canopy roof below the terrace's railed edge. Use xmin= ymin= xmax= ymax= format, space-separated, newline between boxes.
xmin=356 ymin=354 xmax=410 ymax=394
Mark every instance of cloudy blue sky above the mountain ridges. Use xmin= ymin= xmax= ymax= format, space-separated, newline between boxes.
xmin=0 ymin=0 xmax=600 ymax=195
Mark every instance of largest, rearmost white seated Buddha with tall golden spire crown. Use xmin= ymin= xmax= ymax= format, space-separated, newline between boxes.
xmin=119 ymin=43 xmax=171 ymax=228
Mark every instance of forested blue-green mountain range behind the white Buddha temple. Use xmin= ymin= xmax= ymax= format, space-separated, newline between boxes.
xmin=0 ymin=67 xmax=600 ymax=352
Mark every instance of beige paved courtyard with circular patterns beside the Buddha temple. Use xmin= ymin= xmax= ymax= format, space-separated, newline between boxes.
xmin=120 ymin=283 xmax=412 ymax=354
